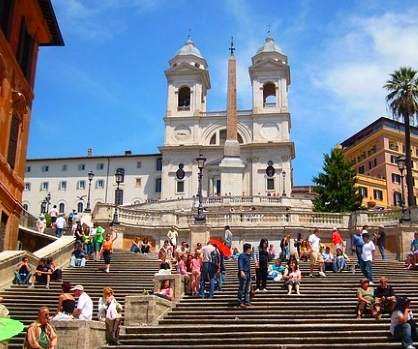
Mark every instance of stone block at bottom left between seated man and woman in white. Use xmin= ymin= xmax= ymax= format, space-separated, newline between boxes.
xmin=51 ymin=320 xmax=106 ymax=349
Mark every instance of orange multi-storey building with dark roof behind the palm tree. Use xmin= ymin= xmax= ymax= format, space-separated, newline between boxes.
xmin=341 ymin=117 xmax=418 ymax=208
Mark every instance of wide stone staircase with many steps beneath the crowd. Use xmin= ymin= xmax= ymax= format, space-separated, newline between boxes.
xmin=2 ymin=251 xmax=418 ymax=349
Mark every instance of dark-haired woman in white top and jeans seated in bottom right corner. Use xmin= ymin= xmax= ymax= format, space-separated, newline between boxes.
xmin=390 ymin=297 xmax=417 ymax=349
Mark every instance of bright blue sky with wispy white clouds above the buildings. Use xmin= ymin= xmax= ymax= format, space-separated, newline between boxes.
xmin=28 ymin=0 xmax=418 ymax=185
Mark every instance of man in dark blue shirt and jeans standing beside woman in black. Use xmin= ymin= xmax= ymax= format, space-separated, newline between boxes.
xmin=238 ymin=243 xmax=251 ymax=309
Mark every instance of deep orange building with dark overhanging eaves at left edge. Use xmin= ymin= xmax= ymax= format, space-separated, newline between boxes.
xmin=0 ymin=0 xmax=64 ymax=252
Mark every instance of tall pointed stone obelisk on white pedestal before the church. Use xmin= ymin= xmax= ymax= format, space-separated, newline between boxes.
xmin=219 ymin=38 xmax=245 ymax=196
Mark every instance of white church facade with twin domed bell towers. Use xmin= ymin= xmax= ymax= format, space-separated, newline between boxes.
xmin=160 ymin=34 xmax=295 ymax=198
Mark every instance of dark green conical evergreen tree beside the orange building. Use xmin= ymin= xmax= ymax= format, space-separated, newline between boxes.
xmin=312 ymin=147 xmax=363 ymax=212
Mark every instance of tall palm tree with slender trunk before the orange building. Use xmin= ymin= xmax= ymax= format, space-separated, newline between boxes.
xmin=384 ymin=67 xmax=418 ymax=207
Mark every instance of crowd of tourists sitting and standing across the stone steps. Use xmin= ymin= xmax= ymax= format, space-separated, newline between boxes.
xmin=15 ymin=220 xmax=418 ymax=349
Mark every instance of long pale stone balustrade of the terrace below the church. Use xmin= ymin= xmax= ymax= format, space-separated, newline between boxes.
xmin=93 ymin=201 xmax=401 ymax=230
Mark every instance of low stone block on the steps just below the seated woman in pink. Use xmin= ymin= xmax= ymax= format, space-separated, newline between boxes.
xmin=124 ymin=295 xmax=175 ymax=326
